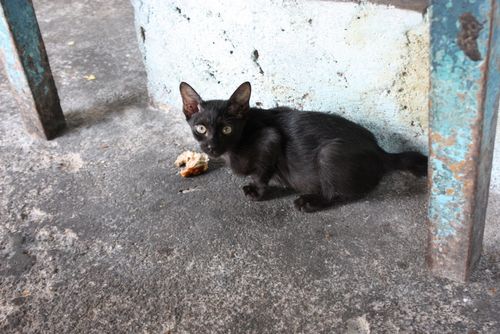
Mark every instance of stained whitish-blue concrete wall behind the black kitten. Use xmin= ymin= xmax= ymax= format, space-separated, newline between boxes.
xmin=131 ymin=0 xmax=500 ymax=189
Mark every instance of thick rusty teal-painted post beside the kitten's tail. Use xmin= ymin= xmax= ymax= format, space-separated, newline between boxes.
xmin=428 ymin=0 xmax=500 ymax=281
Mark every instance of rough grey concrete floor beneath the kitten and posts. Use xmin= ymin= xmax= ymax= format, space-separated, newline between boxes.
xmin=0 ymin=0 xmax=500 ymax=333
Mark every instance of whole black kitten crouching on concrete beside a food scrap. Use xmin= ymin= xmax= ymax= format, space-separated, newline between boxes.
xmin=180 ymin=82 xmax=427 ymax=212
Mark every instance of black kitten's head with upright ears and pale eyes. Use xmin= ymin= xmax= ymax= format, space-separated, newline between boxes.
xmin=179 ymin=82 xmax=251 ymax=157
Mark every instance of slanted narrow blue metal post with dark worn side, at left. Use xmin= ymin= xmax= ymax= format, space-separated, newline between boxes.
xmin=0 ymin=0 xmax=66 ymax=139
